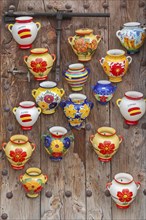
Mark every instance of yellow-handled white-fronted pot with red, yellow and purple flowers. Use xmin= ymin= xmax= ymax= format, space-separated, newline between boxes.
xmin=32 ymin=81 xmax=64 ymax=114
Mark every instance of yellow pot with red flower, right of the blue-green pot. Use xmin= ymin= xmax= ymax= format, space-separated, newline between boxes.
xmin=89 ymin=127 xmax=123 ymax=162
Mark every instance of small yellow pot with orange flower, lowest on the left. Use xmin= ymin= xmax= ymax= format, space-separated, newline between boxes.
xmin=19 ymin=167 xmax=48 ymax=198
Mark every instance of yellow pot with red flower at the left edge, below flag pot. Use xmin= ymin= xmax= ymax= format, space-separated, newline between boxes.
xmin=2 ymin=134 xmax=36 ymax=170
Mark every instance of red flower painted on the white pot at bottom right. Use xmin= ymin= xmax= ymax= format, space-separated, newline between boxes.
xmin=117 ymin=189 xmax=133 ymax=202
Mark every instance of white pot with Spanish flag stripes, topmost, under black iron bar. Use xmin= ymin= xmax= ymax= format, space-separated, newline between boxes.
xmin=8 ymin=16 xmax=41 ymax=49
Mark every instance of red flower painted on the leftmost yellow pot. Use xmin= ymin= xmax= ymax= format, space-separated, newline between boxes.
xmin=10 ymin=148 xmax=27 ymax=163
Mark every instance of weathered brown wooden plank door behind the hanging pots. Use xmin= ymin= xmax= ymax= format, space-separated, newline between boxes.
xmin=0 ymin=0 xmax=146 ymax=220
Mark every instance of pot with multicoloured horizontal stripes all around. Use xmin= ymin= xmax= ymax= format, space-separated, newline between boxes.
xmin=64 ymin=63 xmax=90 ymax=91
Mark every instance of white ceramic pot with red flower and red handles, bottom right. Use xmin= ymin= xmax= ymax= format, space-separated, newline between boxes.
xmin=106 ymin=173 xmax=140 ymax=209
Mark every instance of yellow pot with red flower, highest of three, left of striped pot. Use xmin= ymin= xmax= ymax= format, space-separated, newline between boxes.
xmin=24 ymin=48 xmax=56 ymax=81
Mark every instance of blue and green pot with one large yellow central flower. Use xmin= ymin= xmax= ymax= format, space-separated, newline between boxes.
xmin=43 ymin=126 xmax=74 ymax=161
